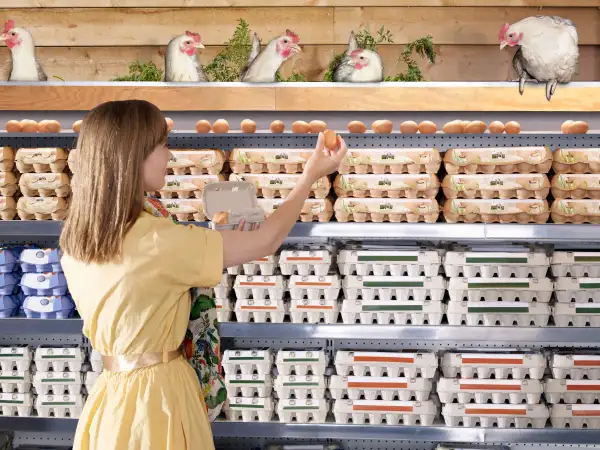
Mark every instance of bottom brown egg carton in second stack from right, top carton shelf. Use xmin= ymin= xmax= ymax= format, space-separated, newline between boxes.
xmin=443 ymin=199 xmax=550 ymax=223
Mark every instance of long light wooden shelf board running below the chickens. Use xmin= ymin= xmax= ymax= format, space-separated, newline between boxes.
xmin=0 ymin=82 xmax=600 ymax=112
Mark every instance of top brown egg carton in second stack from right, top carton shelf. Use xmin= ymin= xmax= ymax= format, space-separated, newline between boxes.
xmin=444 ymin=146 xmax=552 ymax=175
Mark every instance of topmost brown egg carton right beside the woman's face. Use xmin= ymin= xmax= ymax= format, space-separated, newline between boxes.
xmin=167 ymin=149 xmax=227 ymax=175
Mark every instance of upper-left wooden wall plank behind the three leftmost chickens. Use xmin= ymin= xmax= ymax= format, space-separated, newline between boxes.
xmin=0 ymin=8 xmax=333 ymax=47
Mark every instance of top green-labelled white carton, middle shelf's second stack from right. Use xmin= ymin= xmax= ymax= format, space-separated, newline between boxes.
xmin=444 ymin=251 xmax=550 ymax=278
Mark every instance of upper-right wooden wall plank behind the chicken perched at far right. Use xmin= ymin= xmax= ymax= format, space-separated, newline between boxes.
xmin=334 ymin=7 xmax=600 ymax=45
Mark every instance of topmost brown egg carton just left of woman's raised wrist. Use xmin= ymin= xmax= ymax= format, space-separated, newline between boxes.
xmin=229 ymin=148 xmax=313 ymax=174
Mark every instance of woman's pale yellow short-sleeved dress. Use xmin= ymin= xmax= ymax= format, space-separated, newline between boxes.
xmin=62 ymin=212 xmax=223 ymax=450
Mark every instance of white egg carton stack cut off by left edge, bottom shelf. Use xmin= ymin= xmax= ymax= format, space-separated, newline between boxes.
xmin=0 ymin=346 xmax=34 ymax=416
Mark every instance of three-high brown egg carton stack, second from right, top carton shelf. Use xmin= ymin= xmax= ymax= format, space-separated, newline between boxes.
xmin=442 ymin=146 xmax=552 ymax=223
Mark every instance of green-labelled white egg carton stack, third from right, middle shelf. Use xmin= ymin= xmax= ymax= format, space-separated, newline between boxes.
xmin=337 ymin=247 xmax=446 ymax=325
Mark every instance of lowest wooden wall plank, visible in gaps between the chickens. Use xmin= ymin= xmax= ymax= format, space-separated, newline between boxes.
xmin=0 ymin=45 xmax=600 ymax=81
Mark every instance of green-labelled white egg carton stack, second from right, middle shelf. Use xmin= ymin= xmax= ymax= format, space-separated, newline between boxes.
xmin=444 ymin=248 xmax=553 ymax=327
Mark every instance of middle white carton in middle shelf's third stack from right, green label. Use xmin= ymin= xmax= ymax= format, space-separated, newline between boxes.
xmin=342 ymin=275 xmax=446 ymax=301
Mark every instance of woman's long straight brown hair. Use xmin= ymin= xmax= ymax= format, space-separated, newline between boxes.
xmin=60 ymin=100 xmax=168 ymax=264
